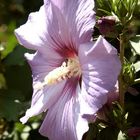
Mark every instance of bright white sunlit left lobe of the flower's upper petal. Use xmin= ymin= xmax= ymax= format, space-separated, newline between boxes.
xmin=15 ymin=6 xmax=47 ymax=50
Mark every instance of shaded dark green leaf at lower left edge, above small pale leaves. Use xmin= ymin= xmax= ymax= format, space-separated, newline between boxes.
xmin=0 ymin=90 xmax=24 ymax=121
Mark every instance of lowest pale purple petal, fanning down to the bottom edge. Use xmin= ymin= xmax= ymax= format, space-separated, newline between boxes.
xmin=40 ymin=78 xmax=88 ymax=140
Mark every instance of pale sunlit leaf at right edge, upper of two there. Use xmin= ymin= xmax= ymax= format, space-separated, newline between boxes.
xmin=130 ymin=35 xmax=140 ymax=55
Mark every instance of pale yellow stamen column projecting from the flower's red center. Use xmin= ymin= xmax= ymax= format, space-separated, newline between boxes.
xmin=35 ymin=57 xmax=81 ymax=89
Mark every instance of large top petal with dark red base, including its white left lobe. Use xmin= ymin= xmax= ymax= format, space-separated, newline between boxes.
xmin=15 ymin=0 xmax=95 ymax=57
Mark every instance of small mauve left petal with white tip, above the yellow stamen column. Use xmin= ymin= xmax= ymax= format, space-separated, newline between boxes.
xmin=25 ymin=51 xmax=64 ymax=80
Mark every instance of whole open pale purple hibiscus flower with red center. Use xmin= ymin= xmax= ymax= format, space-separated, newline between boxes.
xmin=15 ymin=0 xmax=120 ymax=140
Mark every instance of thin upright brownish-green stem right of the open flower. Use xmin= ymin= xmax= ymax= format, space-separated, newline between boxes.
xmin=119 ymin=33 xmax=124 ymax=108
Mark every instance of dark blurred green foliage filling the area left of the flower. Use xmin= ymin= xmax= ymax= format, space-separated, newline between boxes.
xmin=0 ymin=0 xmax=47 ymax=140
